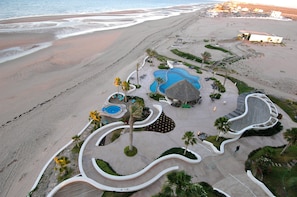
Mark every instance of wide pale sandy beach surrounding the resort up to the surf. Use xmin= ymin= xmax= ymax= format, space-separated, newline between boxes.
xmin=0 ymin=3 xmax=297 ymax=196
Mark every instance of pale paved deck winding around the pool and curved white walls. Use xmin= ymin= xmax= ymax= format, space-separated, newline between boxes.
xmin=49 ymin=60 xmax=286 ymax=197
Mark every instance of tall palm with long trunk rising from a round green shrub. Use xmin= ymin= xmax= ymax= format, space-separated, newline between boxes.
xmin=129 ymin=102 xmax=143 ymax=151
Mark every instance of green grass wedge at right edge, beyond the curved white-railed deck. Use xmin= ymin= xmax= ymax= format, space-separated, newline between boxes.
xmin=268 ymin=95 xmax=297 ymax=122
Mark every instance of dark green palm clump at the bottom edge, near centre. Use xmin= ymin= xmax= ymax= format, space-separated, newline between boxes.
xmin=154 ymin=171 xmax=207 ymax=197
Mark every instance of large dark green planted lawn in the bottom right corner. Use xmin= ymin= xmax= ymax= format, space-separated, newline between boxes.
xmin=246 ymin=146 xmax=297 ymax=196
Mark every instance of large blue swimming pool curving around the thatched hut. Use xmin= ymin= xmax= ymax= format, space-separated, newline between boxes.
xmin=150 ymin=68 xmax=200 ymax=94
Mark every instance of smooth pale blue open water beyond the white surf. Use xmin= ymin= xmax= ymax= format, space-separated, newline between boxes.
xmin=0 ymin=0 xmax=219 ymax=19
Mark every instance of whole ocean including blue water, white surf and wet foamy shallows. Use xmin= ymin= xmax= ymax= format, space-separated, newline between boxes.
xmin=0 ymin=0 xmax=224 ymax=64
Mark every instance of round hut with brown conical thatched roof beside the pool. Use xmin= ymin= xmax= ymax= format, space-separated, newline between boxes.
xmin=165 ymin=79 xmax=201 ymax=104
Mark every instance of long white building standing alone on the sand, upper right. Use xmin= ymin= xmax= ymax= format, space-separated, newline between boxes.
xmin=238 ymin=31 xmax=283 ymax=43
